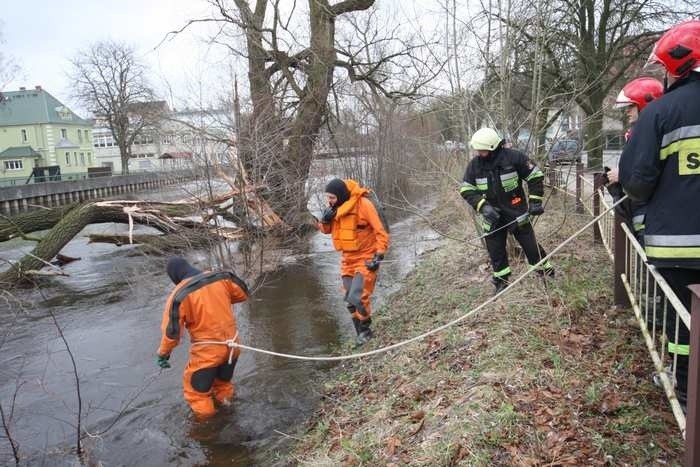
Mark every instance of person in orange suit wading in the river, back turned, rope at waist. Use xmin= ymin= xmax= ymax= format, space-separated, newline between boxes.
xmin=157 ymin=257 xmax=248 ymax=419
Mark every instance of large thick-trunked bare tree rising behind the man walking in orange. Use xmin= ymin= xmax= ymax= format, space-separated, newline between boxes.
xmin=165 ymin=0 xmax=434 ymax=226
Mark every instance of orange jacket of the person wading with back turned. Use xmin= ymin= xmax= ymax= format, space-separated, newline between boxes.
xmin=158 ymin=273 xmax=248 ymax=355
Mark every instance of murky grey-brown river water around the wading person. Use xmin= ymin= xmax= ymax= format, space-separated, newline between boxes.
xmin=0 ymin=181 xmax=435 ymax=466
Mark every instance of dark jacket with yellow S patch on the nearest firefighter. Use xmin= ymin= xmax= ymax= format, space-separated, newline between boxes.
xmin=619 ymin=72 xmax=700 ymax=269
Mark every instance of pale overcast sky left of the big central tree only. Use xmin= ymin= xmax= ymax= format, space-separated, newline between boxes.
xmin=0 ymin=0 xmax=232 ymax=111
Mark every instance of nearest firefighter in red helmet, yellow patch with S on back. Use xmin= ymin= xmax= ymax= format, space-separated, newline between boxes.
xmin=620 ymin=20 xmax=700 ymax=408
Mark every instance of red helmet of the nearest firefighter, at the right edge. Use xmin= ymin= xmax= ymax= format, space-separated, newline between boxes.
xmin=647 ymin=20 xmax=700 ymax=78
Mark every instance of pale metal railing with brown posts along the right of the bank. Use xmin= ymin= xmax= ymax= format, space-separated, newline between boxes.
xmin=548 ymin=163 xmax=700 ymax=466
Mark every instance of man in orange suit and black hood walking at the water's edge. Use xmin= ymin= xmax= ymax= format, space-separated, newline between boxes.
xmin=318 ymin=178 xmax=389 ymax=344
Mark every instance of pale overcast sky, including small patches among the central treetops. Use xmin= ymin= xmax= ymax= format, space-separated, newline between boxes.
xmin=0 ymin=0 xmax=439 ymax=117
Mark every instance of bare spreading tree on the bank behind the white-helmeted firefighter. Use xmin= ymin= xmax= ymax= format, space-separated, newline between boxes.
xmin=496 ymin=0 xmax=690 ymax=167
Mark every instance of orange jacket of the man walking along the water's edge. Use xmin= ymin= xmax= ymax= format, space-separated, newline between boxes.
xmin=318 ymin=180 xmax=389 ymax=257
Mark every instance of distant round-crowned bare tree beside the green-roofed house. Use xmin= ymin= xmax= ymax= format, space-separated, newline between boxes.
xmin=71 ymin=41 xmax=158 ymax=174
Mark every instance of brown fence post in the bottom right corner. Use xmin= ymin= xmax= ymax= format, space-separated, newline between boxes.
xmin=685 ymin=284 xmax=700 ymax=467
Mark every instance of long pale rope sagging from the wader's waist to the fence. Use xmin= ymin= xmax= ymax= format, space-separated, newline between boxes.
xmin=220 ymin=196 xmax=627 ymax=362
